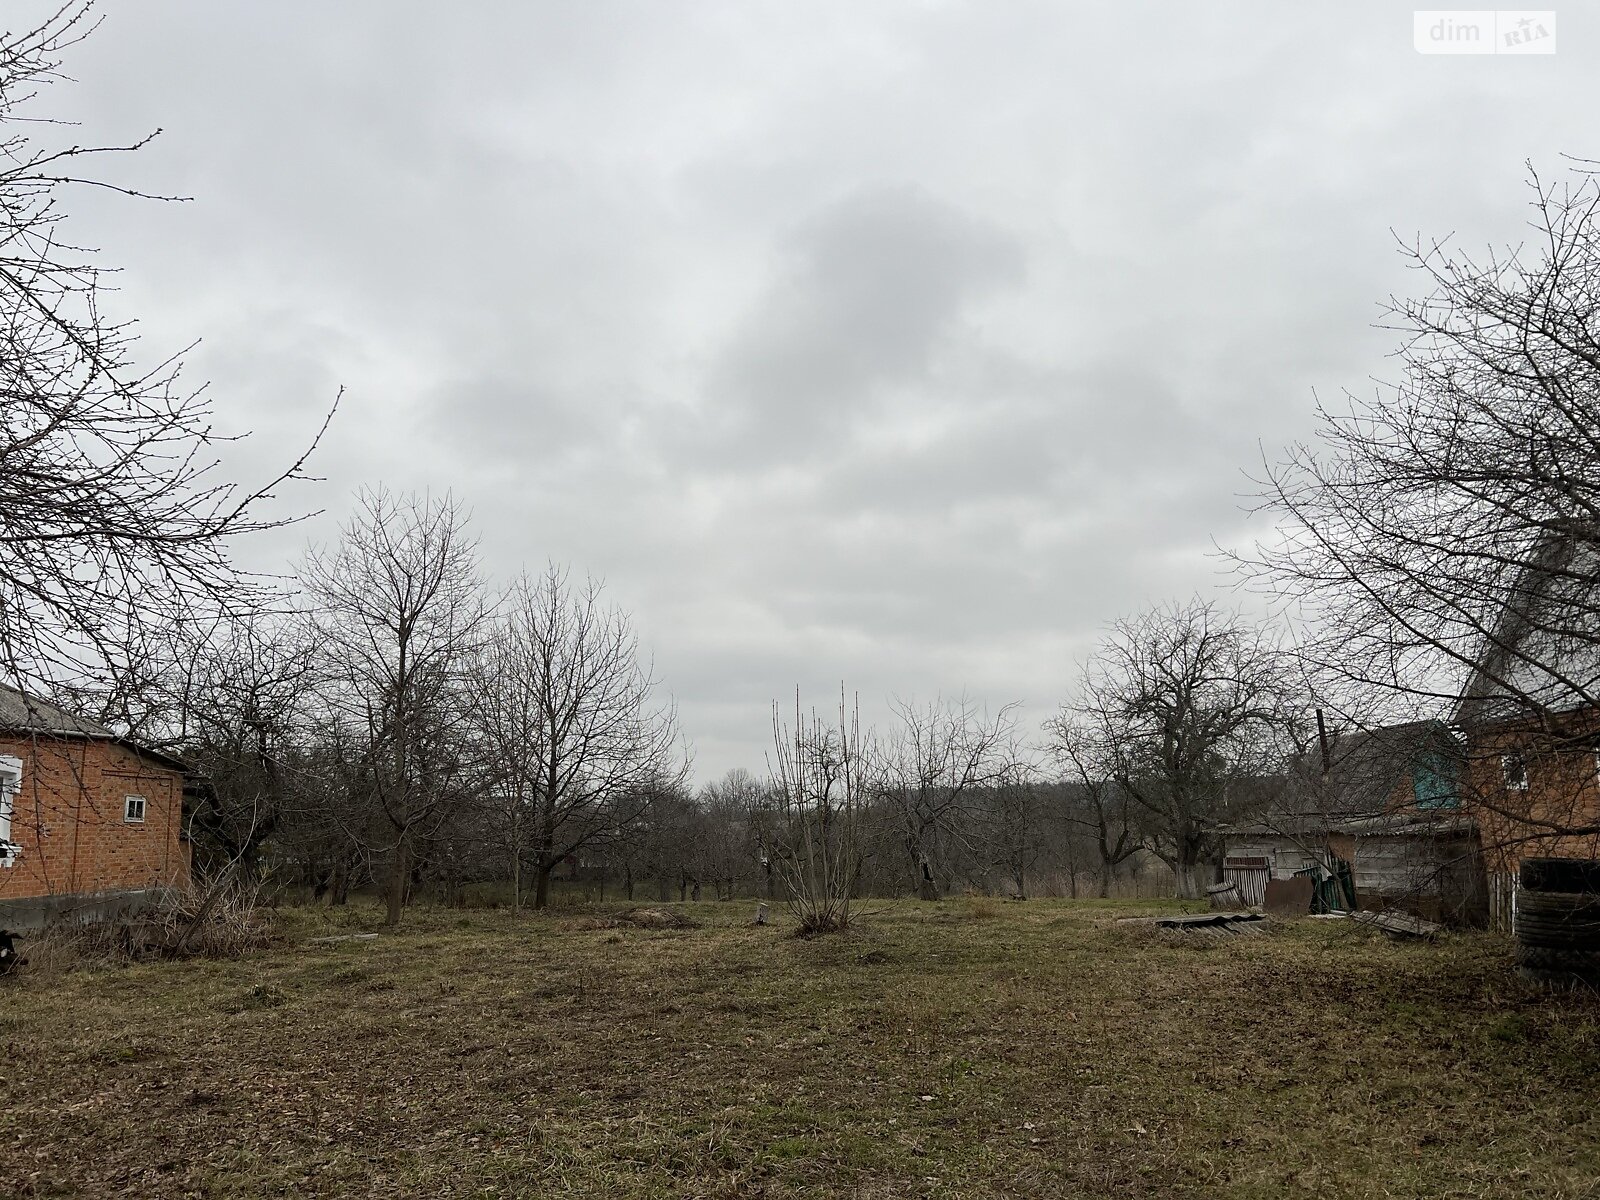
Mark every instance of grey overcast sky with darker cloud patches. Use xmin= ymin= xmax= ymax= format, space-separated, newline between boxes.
xmin=21 ymin=0 xmax=1600 ymax=781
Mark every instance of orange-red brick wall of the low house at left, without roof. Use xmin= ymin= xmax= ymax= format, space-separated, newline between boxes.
xmin=0 ymin=736 xmax=189 ymax=899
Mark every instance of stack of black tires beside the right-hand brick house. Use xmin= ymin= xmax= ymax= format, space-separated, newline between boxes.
xmin=1512 ymin=858 xmax=1600 ymax=989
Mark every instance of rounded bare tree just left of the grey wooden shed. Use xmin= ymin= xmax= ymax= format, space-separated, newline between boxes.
xmin=1058 ymin=600 xmax=1294 ymax=898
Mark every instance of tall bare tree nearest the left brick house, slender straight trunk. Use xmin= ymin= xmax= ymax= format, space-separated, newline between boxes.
xmin=304 ymin=488 xmax=488 ymax=925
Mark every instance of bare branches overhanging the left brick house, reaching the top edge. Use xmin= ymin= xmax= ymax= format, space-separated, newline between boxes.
xmin=0 ymin=3 xmax=331 ymax=690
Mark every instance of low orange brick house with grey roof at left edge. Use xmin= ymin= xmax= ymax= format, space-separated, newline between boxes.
xmin=0 ymin=686 xmax=189 ymax=928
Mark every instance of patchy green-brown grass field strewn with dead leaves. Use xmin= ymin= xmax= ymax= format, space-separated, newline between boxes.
xmin=0 ymin=901 xmax=1600 ymax=1197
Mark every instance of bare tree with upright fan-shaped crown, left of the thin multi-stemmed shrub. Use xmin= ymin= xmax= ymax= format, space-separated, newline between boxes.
xmin=491 ymin=565 xmax=688 ymax=909
